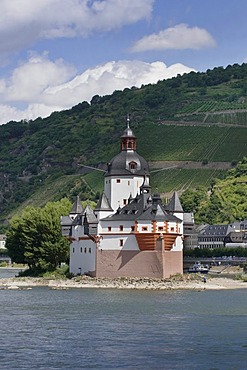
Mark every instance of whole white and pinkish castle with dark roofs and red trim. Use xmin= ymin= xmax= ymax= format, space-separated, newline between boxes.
xmin=61 ymin=124 xmax=184 ymax=278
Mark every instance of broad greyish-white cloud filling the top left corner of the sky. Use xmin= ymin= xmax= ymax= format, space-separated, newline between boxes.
xmin=0 ymin=0 xmax=154 ymax=54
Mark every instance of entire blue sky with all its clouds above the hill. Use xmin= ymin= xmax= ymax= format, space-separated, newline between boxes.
xmin=0 ymin=0 xmax=247 ymax=124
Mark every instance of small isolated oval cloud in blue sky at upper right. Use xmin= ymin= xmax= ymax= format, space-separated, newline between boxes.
xmin=131 ymin=24 xmax=216 ymax=52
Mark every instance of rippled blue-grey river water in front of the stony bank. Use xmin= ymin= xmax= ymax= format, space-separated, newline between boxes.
xmin=0 ymin=271 xmax=247 ymax=370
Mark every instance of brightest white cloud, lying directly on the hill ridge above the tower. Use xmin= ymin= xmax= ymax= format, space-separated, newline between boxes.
xmin=44 ymin=60 xmax=192 ymax=105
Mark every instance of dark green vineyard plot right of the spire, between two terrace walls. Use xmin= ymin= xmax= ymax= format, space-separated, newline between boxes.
xmin=135 ymin=124 xmax=247 ymax=162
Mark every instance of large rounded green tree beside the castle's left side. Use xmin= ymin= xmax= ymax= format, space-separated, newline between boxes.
xmin=6 ymin=199 xmax=71 ymax=272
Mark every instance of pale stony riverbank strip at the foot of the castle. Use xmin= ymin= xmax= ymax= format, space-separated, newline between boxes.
xmin=0 ymin=274 xmax=247 ymax=290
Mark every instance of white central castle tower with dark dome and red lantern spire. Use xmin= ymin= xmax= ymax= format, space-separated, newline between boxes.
xmin=104 ymin=119 xmax=149 ymax=212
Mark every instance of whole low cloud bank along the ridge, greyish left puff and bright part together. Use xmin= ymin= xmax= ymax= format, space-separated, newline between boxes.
xmin=0 ymin=55 xmax=195 ymax=124
